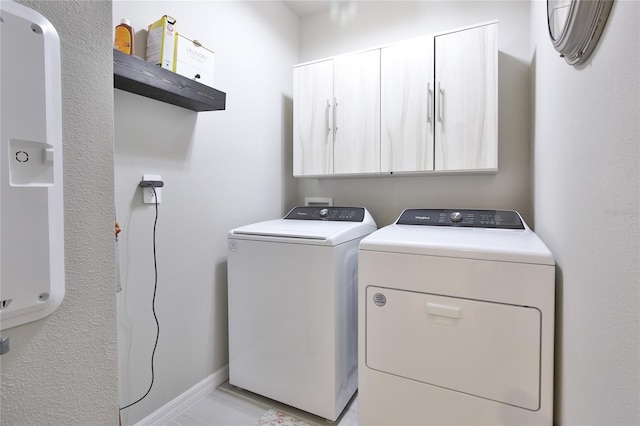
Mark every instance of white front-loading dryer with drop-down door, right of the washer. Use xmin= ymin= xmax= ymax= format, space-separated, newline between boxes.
xmin=358 ymin=209 xmax=555 ymax=426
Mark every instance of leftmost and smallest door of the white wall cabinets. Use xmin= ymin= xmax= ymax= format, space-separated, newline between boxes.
xmin=293 ymin=60 xmax=333 ymax=176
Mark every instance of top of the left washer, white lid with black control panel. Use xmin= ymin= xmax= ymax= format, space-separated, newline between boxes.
xmin=229 ymin=206 xmax=376 ymax=246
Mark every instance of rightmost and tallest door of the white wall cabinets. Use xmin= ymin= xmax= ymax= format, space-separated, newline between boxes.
xmin=435 ymin=24 xmax=498 ymax=170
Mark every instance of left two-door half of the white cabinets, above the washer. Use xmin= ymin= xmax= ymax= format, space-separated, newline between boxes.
xmin=293 ymin=49 xmax=380 ymax=176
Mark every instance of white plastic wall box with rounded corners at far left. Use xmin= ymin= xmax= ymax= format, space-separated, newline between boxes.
xmin=0 ymin=0 xmax=65 ymax=329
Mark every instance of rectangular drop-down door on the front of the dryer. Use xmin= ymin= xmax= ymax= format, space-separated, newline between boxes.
xmin=365 ymin=286 xmax=541 ymax=410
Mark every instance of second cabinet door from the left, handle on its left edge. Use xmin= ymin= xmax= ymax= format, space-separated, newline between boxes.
xmin=333 ymin=49 xmax=380 ymax=174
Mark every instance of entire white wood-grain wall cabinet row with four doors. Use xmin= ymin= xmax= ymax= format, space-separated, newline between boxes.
xmin=293 ymin=22 xmax=498 ymax=176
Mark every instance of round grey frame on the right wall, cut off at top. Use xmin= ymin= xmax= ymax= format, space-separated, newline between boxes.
xmin=547 ymin=0 xmax=613 ymax=65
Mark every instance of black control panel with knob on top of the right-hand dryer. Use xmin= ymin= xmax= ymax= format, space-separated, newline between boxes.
xmin=396 ymin=209 xmax=525 ymax=229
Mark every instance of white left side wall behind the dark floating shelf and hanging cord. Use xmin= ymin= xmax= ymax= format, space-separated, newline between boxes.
xmin=112 ymin=1 xmax=298 ymax=424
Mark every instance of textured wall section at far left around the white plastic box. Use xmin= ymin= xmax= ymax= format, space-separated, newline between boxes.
xmin=0 ymin=1 xmax=118 ymax=426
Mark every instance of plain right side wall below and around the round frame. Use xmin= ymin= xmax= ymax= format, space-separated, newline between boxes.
xmin=531 ymin=0 xmax=640 ymax=425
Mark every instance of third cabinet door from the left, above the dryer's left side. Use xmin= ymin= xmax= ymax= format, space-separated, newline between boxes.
xmin=380 ymin=36 xmax=434 ymax=172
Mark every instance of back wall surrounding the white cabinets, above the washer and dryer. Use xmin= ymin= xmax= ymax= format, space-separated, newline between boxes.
xmin=298 ymin=1 xmax=533 ymax=226
